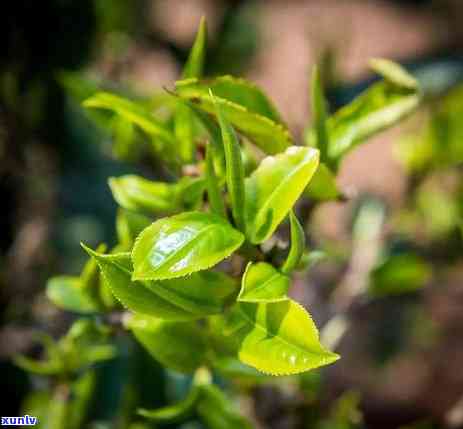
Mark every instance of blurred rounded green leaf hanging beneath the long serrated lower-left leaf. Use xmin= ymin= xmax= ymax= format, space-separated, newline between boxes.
xmin=127 ymin=315 xmax=207 ymax=373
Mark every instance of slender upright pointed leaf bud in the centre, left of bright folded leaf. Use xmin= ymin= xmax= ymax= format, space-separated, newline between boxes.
xmin=211 ymin=89 xmax=245 ymax=231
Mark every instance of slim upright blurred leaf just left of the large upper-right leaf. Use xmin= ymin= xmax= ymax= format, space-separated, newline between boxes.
xmin=311 ymin=67 xmax=329 ymax=162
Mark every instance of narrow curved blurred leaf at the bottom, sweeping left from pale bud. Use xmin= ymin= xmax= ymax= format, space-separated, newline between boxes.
xmin=138 ymin=386 xmax=201 ymax=424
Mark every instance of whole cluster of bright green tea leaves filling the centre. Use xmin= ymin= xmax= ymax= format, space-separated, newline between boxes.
xmin=19 ymin=21 xmax=421 ymax=428
